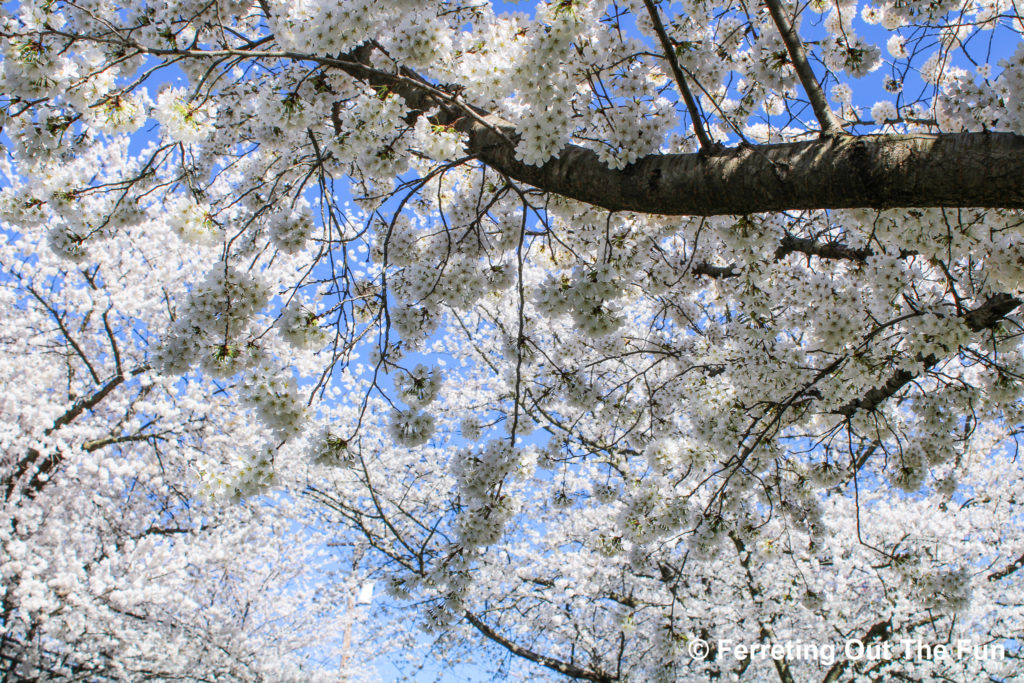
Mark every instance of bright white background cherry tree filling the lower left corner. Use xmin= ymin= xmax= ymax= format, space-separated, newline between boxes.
xmin=0 ymin=197 xmax=382 ymax=681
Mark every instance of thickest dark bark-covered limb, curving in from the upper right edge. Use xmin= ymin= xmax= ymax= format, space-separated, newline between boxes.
xmin=329 ymin=47 xmax=1024 ymax=216
